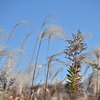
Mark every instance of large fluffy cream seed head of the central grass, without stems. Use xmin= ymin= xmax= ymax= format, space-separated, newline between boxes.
xmin=41 ymin=25 xmax=66 ymax=41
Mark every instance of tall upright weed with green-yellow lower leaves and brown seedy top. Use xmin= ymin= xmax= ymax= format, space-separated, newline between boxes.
xmin=65 ymin=30 xmax=87 ymax=100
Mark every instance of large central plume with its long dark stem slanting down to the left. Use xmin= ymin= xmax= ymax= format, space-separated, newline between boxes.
xmin=32 ymin=15 xmax=65 ymax=97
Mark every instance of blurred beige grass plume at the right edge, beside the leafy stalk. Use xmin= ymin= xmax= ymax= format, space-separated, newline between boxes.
xmin=83 ymin=46 xmax=100 ymax=98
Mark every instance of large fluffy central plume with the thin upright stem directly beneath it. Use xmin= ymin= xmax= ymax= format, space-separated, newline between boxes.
xmin=42 ymin=25 xmax=66 ymax=100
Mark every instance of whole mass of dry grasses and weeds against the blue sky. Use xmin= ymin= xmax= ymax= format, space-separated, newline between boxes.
xmin=0 ymin=14 xmax=100 ymax=100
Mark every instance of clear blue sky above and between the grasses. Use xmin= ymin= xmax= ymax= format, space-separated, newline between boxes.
xmin=0 ymin=0 xmax=100 ymax=83
